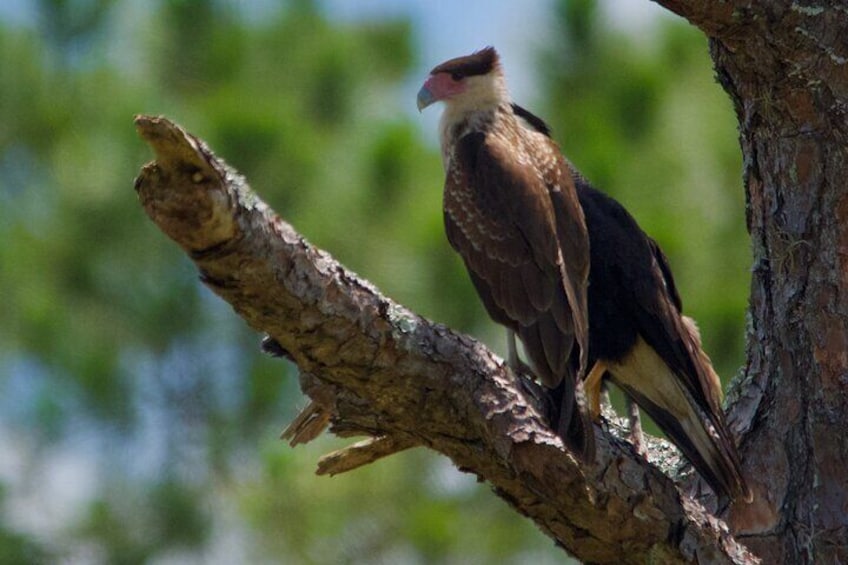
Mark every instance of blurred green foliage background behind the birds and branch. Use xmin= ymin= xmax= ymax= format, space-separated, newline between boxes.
xmin=0 ymin=0 xmax=748 ymax=563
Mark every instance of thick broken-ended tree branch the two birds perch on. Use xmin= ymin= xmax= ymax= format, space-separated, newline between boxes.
xmin=135 ymin=116 xmax=755 ymax=563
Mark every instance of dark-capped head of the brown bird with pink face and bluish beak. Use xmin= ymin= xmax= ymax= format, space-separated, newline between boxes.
xmin=418 ymin=47 xmax=509 ymax=113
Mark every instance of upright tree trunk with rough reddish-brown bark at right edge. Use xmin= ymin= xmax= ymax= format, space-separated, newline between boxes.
xmin=658 ymin=0 xmax=848 ymax=563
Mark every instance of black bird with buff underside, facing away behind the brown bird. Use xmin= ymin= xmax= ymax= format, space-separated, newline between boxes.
xmin=572 ymin=168 xmax=752 ymax=502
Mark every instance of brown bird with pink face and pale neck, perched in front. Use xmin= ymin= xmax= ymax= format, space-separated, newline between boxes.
xmin=417 ymin=47 xmax=595 ymax=461
